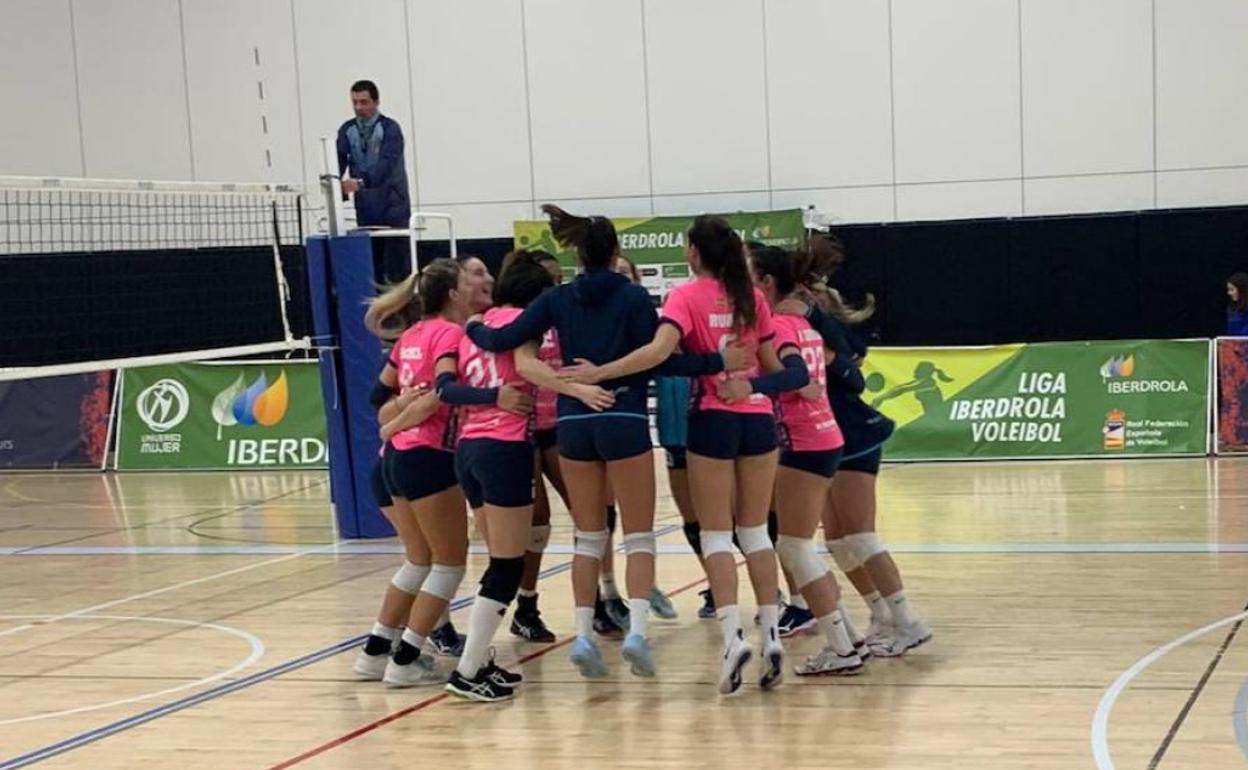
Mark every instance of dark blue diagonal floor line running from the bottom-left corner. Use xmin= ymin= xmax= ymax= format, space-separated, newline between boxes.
xmin=0 ymin=524 xmax=680 ymax=770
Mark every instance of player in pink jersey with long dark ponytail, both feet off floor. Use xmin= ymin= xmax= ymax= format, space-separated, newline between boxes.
xmin=571 ymin=216 xmax=810 ymax=694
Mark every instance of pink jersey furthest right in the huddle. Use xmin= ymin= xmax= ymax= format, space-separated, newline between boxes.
xmin=771 ymin=316 xmax=845 ymax=452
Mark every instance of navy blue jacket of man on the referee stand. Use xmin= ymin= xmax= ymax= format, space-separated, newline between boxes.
xmin=337 ymin=115 xmax=412 ymax=227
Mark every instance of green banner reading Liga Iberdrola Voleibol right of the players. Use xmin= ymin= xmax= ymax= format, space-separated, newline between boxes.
xmin=862 ymin=339 xmax=1209 ymax=461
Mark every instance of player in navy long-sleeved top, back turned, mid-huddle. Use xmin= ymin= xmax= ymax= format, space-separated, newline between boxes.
xmin=467 ymin=205 xmax=724 ymax=678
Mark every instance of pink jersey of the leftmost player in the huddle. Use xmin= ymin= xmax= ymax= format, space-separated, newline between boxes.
xmin=389 ymin=318 xmax=464 ymax=449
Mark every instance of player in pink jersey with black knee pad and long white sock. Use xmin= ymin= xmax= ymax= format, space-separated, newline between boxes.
xmin=438 ymin=252 xmax=615 ymax=701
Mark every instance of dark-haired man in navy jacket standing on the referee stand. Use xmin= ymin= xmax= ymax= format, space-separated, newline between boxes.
xmin=337 ymin=80 xmax=412 ymax=282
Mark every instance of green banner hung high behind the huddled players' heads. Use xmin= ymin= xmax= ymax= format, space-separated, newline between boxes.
xmin=513 ymin=208 xmax=806 ymax=297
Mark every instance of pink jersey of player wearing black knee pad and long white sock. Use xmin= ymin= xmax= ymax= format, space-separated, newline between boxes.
xmin=459 ymin=307 xmax=529 ymax=441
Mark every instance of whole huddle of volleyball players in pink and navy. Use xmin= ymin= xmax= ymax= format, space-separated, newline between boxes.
xmin=354 ymin=206 xmax=931 ymax=701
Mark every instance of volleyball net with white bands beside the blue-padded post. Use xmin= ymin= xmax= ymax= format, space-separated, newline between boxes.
xmin=0 ymin=176 xmax=312 ymax=382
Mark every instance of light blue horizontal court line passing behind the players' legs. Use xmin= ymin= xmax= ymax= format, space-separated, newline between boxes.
xmin=7 ymin=541 xmax=1248 ymax=557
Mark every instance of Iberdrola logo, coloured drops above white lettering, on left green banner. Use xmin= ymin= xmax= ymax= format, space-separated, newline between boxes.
xmin=212 ymin=369 xmax=327 ymax=465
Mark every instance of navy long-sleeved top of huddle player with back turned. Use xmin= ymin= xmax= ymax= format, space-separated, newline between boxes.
xmin=466 ymin=268 xmax=724 ymax=417
